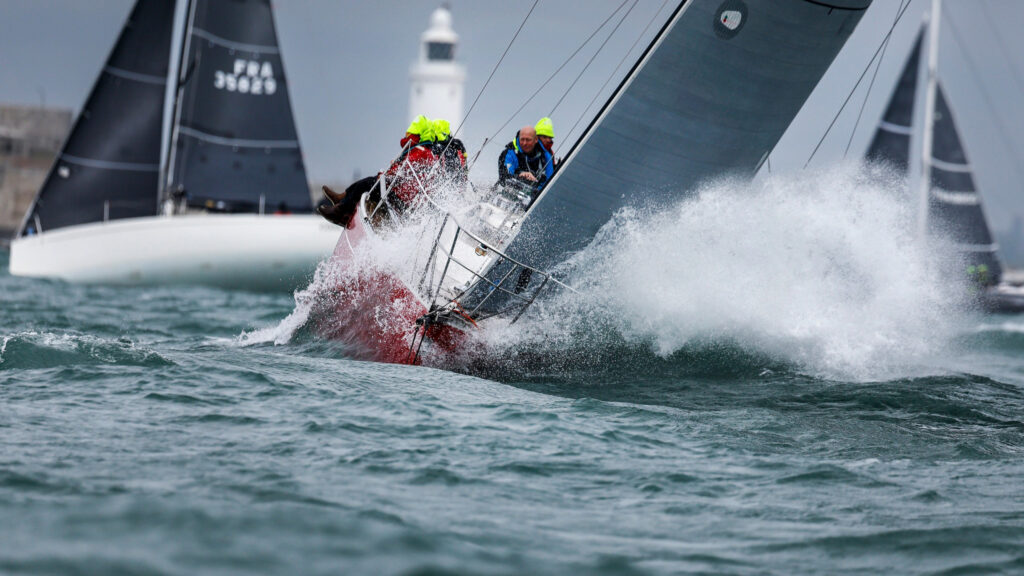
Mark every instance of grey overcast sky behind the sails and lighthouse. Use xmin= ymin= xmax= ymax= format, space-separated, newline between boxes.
xmin=0 ymin=0 xmax=1024 ymax=229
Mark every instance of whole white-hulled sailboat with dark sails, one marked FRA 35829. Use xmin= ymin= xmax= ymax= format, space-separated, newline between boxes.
xmin=10 ymin=0 xmax=338 ymax=289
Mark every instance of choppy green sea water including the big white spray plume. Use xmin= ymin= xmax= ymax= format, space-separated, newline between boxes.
xmin=0 ymin=171 xmax=1024 ymax=574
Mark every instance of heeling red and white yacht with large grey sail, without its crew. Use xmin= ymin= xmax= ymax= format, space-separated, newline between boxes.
xmin=322 ymin=0 xmax=870 ymax=362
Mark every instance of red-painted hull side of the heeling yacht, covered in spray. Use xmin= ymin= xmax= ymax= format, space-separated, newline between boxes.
xmin=315 ymin=217 xmax=467 ymax=364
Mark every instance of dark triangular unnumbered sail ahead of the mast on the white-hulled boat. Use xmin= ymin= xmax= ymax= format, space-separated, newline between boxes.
xmin=20 ymin=0 xmax=174 ymax=236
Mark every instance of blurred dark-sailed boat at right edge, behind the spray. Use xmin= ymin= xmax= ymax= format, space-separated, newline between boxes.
xmin=866 ymin=0 xmax=1024 ymax=311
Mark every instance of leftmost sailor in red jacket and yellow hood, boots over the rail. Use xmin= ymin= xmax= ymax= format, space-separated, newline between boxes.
xmin=316 ymin=115 xmax=437 ymax=228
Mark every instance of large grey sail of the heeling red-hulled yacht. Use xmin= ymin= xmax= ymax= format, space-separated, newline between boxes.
xmin=460 ymin=0 xmax=870 ymax=315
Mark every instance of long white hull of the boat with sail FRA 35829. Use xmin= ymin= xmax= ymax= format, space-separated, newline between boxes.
xmin=10 ymin=214 xmax=338 ymax=291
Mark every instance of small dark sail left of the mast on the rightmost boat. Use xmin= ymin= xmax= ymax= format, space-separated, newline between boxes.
xmin=866 ymin=31 xmax=925 ymax=173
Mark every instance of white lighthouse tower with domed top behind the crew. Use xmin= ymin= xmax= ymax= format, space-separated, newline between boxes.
xmin=409 ymin=4 xmax=466 ymax=126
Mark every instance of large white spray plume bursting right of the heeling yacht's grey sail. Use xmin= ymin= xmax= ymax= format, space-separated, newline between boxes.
xmin=485 ymin=167 xmax=964 ymax=380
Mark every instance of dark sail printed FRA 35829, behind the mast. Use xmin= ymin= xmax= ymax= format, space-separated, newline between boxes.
xmin=165 ymin=0 xmax=312 ymax=212
